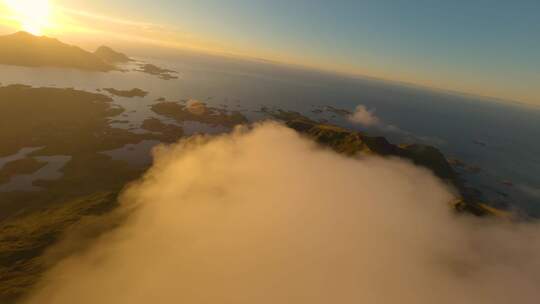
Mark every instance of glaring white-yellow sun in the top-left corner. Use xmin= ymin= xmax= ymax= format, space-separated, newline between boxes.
xmin=4 ymin=0 xmax=51 ymax=36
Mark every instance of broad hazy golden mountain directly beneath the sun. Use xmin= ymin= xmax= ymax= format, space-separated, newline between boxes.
xmin=0 ymin=32 xmax=116 ymax=72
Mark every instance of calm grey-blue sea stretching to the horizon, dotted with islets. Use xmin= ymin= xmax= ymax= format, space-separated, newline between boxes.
xmin=0 ymin=55 xmax=540 ymax=216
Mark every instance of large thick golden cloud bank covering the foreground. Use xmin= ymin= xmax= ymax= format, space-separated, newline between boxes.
xmin=24 ymin=123 xmax=540 ymax=304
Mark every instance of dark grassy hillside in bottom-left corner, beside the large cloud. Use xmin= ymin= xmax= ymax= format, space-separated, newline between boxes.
xmin=0 ymin=192 xmax=121 ymax=303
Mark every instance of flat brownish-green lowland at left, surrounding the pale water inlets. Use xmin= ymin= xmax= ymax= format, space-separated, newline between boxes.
xmin=0 ymin=85 xmax=155 ymax=220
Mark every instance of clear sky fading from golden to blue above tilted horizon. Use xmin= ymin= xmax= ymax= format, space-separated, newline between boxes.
xmin=0 ymin=0 xmax=540 ymax=104
